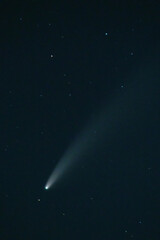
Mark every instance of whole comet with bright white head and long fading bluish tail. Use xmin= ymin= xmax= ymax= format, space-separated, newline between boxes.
xmin=45 ymin=74 xmax=150 ymax=190
